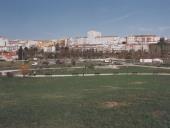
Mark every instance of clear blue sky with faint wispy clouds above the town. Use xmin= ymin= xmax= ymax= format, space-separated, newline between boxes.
xmin=0 ymin=0 xmax=170 ymax=39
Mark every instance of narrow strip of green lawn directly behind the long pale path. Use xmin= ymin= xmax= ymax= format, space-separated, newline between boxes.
xmin=34 ymin=66 xmax=170 ymax=75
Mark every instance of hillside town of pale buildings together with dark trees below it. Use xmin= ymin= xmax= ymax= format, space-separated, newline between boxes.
xmin=0 ymin=31 xmax=170 ymax=62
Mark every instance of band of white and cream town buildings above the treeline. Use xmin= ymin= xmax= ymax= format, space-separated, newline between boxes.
xmin=0 ymin=31 xmax=163 ymax=52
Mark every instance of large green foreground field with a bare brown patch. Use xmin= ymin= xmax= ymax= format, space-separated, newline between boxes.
xmin=0 ymin=76 xmax=170 ymax=128
